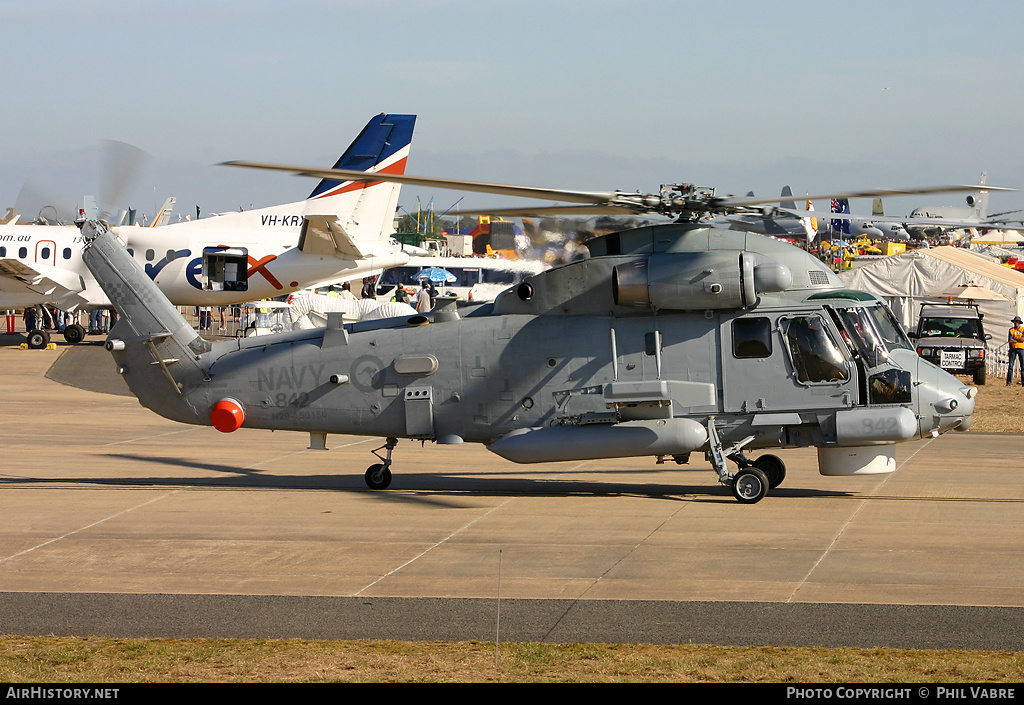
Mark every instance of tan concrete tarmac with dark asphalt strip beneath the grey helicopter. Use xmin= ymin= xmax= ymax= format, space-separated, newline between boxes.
xmin=6 ymin=336 xmax=1024 ymax=650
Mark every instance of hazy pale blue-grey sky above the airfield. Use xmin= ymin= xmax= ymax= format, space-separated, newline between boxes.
xmin=0 ymin=0 xmax=1024 ymax=221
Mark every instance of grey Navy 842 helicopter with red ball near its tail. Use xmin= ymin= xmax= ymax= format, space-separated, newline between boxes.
xmin=75 ymin=163 xmax=977 ymax=503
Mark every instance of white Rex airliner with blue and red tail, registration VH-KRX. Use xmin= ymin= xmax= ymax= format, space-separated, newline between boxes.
xmin=0 ymin=115 xmax=416 ymax=347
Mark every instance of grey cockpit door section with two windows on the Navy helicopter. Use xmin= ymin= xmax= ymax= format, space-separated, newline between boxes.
xmin=722 ymin=310 xmax=858 ymax=414
